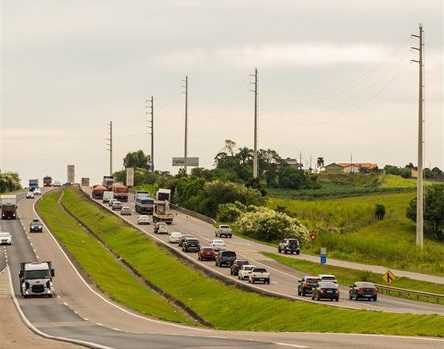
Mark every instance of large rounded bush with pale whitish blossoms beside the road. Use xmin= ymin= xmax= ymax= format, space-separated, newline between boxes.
xmin=235 ymin=207 xmax=308 ymax=242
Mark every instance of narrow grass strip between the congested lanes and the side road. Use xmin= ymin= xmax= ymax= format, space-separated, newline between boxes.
xmin=262 ymin=252 xmax=444 ymax=304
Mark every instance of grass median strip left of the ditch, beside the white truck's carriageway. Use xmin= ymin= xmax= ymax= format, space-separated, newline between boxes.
xmin=37 ymin=191 xmax=193 ymax=323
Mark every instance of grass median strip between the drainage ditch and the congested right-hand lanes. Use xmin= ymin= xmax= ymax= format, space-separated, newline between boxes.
xmin=58 ymin=189 xmax=444 ymax=336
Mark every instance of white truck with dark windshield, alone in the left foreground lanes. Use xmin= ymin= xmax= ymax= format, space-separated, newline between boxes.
xmin=19 ymin=262 xmax=55 ymax=298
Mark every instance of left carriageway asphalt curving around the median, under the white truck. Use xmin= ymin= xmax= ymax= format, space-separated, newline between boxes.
xmin=1 ymin=188 xmax=444 ymax=349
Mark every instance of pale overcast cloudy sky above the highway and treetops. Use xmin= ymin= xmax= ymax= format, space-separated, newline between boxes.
xmin=0 ymin=0 xmax=444 ymax=182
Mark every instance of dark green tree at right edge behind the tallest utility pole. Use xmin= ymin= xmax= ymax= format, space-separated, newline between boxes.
xmin=406 ymin=184 xmax=444 ymax=240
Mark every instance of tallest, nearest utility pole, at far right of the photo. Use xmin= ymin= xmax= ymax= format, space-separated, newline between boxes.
xmin=412 ymin=24 xmax=424 ymax=249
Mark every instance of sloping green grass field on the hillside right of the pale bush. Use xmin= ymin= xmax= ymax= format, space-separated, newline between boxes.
xmin=270 ymin=193 xmax=444 ymax=275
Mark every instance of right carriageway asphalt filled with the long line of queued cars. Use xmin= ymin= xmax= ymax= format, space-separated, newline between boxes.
xmin=88 ymin=188 xmax=444 ymax=315
